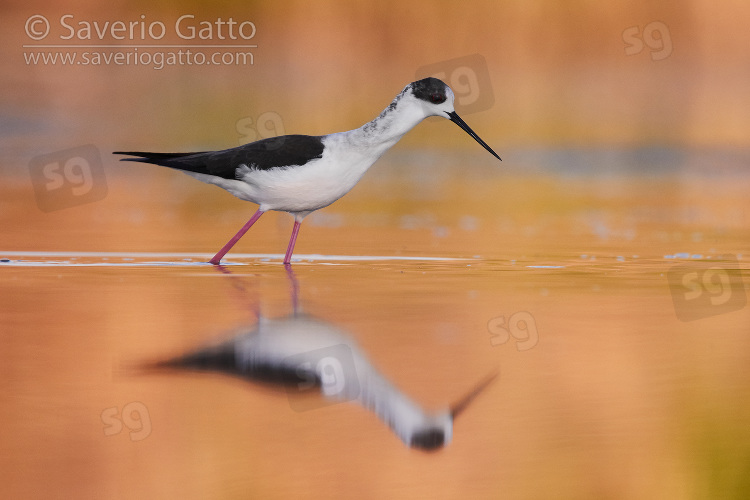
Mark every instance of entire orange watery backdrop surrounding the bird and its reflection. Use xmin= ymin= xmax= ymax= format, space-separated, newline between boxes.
xmin=0 ymin=0 xmax=750 ymax=498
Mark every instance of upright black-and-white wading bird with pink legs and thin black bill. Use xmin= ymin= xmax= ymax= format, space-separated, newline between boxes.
xmin=113 ymin=77 xmax=501 ymax=265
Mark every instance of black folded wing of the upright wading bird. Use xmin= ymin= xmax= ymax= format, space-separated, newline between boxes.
xmin=113 ymin=135 xmax=323 ymax=179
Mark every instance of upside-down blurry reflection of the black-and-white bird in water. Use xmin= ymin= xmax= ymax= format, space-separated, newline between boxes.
xmin=151 ymin=267 xmax=497 ymax=450
